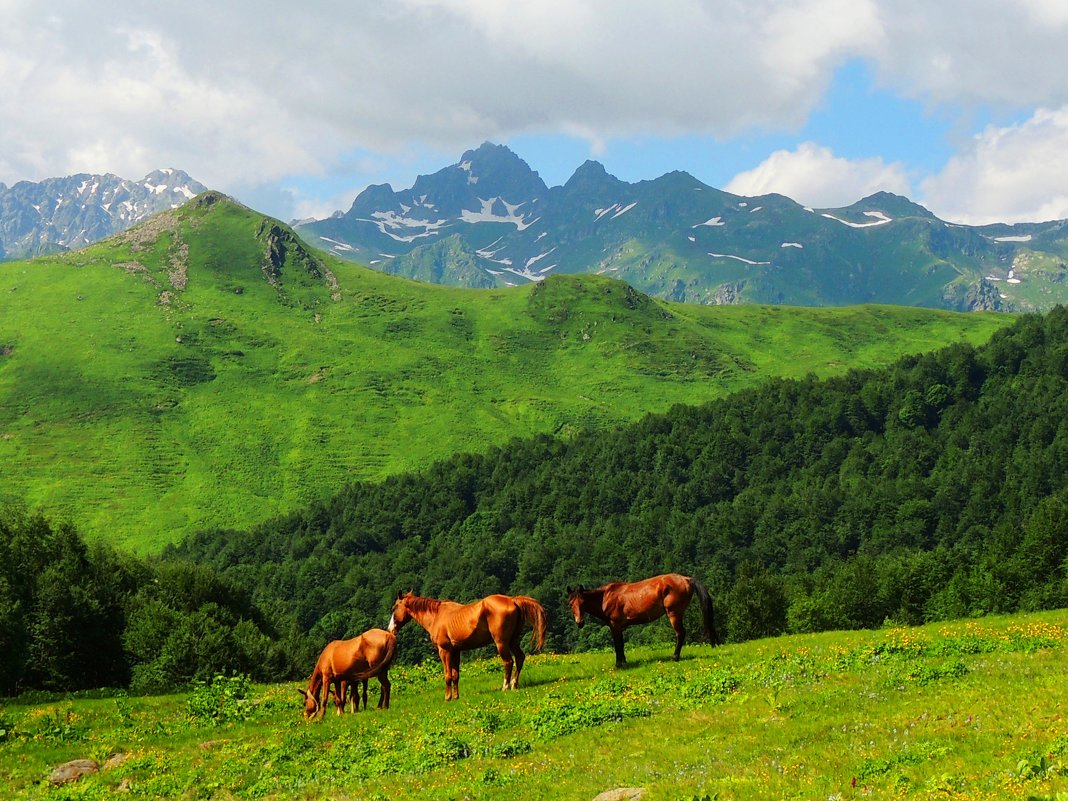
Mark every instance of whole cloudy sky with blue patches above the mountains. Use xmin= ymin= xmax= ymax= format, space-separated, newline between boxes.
xmin=0 ymin=0 xmax=1068 ymax=224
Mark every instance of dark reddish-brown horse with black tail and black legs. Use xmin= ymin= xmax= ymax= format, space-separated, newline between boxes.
xmin=567 ymin=572 xmax=718 ymax=668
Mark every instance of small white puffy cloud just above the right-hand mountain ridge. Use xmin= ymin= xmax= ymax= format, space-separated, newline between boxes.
xmin=724 ymin=142 xmax=910 ymax=208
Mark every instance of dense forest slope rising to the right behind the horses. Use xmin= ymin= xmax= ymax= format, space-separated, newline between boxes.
xmin=169 ymin=309 xmax=1068 ymax=656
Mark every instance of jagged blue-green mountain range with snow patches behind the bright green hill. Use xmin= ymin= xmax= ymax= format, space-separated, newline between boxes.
xmin=297 ymin=143 xmax=1068 ymax=311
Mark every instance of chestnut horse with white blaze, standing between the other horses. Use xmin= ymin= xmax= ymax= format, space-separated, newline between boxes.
xmin=389 ymin=592 xmax=546 ymax=701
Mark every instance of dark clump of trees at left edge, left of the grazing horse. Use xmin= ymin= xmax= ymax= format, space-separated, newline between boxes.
xmin=0 ymin=507 xmax=314 ymax=695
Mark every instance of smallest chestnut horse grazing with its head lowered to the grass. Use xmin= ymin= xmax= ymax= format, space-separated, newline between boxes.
xmin=297 ymin=629 xmax=397 ymax=720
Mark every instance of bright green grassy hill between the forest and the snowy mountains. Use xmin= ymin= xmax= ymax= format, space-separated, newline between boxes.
xmin=0 ymin=197 xmax=1010 ymax=551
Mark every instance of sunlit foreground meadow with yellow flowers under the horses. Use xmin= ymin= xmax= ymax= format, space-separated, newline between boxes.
xmin=0 ymin=611 xmax=1068 ymax=801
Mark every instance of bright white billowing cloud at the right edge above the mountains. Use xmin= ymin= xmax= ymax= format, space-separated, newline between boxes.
xmin=920 ymin=107 xmax=1068 ymax=224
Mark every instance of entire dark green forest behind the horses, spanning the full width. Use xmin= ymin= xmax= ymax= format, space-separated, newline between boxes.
xmin=0 ymin=308 xmax=1068 ymax=693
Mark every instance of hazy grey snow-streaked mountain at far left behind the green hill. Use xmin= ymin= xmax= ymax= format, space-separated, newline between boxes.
xmin=0 ymin=170 xmax=205 ymax=260
